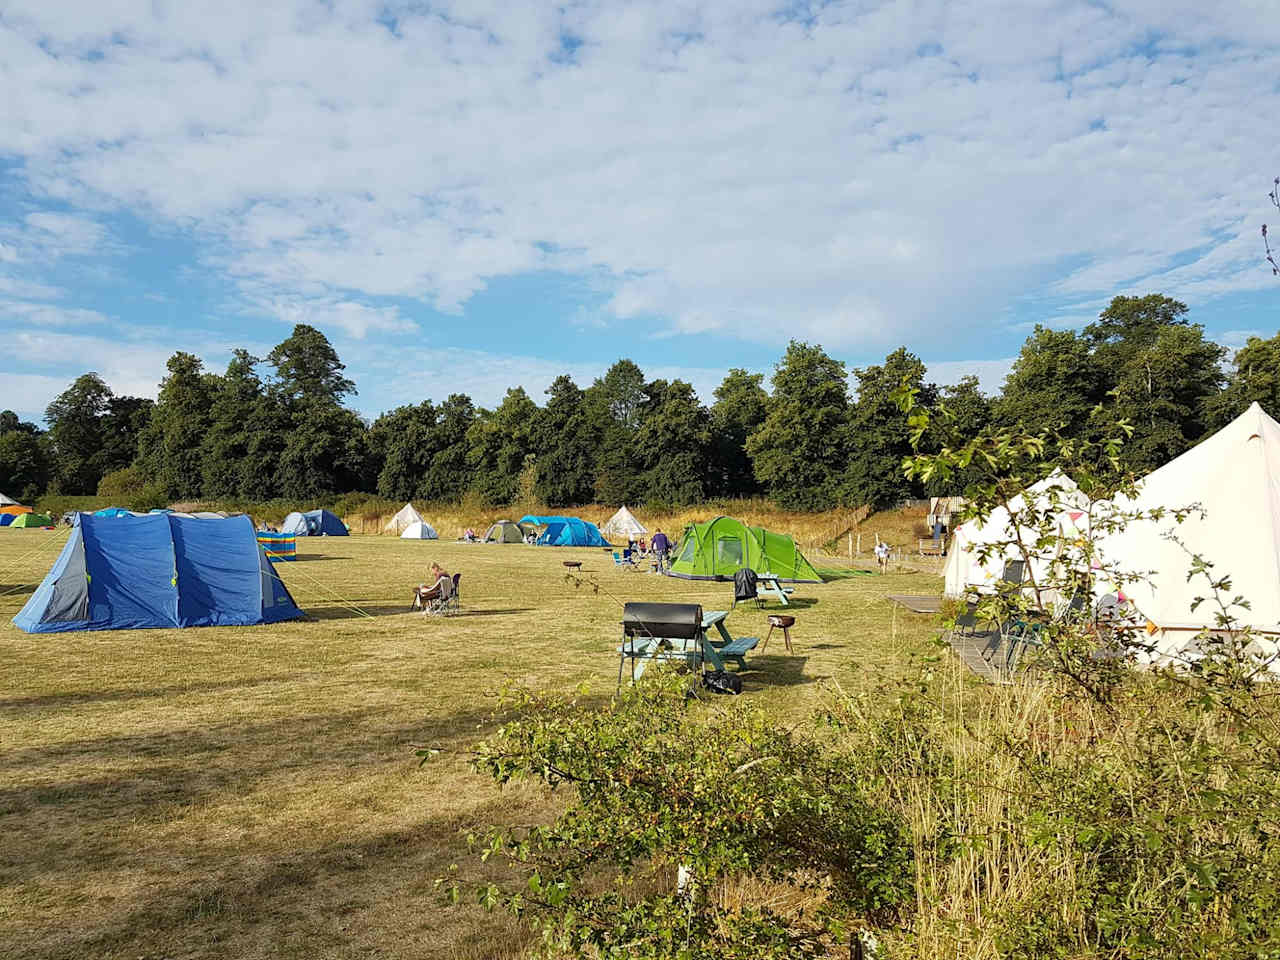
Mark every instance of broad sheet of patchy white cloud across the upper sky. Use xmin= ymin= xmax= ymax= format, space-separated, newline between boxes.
xmin=0 ymin=0 xmax=1280 ymax=358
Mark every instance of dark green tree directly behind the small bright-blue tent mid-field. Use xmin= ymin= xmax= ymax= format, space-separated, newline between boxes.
xmin=534 ymin=375 xmax=599 ymax=506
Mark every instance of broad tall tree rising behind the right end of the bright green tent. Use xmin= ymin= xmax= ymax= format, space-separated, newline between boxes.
xmin=746 ymin=340 xmax=849 ymax=509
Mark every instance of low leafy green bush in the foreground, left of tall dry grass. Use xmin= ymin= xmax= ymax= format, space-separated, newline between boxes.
xmin=437 ymin=681 xmax=913 ymax=960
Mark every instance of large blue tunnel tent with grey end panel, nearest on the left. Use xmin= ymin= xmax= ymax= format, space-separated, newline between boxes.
xmin=13 ymin=513 xmax=302 ymax=634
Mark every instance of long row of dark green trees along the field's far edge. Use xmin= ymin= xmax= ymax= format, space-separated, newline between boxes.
xmin=0 ymin=294 xmax=1280 ymax=509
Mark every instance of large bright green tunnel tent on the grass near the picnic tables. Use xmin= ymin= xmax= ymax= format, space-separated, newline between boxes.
xmin=667 ymin=517 xmax=822 ymax=584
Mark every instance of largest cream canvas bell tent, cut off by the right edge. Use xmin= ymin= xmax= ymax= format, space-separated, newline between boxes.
xmin=1097 ymin=403 xmax=1280 ymax=660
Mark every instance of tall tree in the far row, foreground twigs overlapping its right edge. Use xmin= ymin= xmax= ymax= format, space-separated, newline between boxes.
xmin=841 ymin=347 xmax=937 ymax=509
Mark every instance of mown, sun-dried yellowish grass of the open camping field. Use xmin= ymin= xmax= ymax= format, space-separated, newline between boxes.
xmin=0 ymin=530 xmax=955 ymax=960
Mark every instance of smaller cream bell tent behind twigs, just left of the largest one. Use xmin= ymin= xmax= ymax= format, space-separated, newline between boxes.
xmin=945 ymin=471 xmax=1088 ymax=598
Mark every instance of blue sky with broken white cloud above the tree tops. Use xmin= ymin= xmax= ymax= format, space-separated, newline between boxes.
xmin=0 ymin=0 xmax=1280 ymax=419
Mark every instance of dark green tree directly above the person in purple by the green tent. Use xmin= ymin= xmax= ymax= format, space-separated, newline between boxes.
xmin=636 ymin=380 xmax=710 ymax=507
